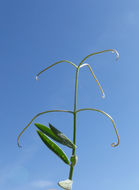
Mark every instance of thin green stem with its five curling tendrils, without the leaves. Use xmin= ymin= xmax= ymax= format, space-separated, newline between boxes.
xmin=17 ymin=49 xmax=120 ymax=187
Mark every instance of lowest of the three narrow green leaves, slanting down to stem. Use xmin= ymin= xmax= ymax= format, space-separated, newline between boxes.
xmin=37 ymin=130 xmax=70 ymax=165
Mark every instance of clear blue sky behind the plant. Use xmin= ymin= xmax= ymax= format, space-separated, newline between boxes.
xmin=0 ymin=0 xmax=139 ymax=190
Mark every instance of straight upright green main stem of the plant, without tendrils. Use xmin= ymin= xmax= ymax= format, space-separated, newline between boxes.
xmin=69 ymin=66 xmax=79 ymax=180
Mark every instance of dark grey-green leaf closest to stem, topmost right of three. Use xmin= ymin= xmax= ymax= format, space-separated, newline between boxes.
xmin=49 ymin=123 xmax=76 ymax=148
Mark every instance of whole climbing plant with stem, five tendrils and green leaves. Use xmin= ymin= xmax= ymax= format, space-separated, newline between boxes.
xmin=17 ymin=49 xmax=120 ymax=190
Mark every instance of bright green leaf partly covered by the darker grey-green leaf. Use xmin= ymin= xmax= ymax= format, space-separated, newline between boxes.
xmin=34 ymin=123 xmax=61 ymax=143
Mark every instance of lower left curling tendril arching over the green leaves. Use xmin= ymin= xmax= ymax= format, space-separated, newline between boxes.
xmin=17 ymin=110 xmax=74 ymax=147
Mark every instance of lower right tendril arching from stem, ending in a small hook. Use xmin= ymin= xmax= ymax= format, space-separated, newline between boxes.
xmin=76 ymin=108 xmax=120 ymax=147
